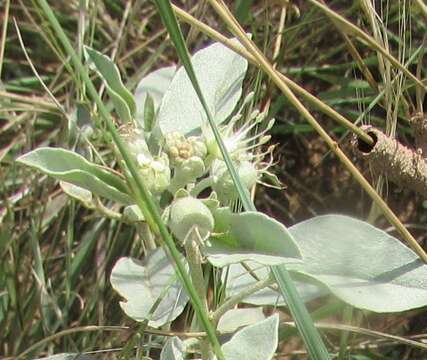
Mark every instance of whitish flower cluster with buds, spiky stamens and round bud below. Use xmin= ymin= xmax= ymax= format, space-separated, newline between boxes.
xmin=122 ymin=94 xmax=280 ymax=241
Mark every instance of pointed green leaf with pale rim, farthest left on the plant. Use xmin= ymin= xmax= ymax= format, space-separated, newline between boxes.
xmin=16 ymin=147 xmax=132 ymax=204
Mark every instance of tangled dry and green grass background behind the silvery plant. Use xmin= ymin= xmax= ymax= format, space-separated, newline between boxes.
xmin=0 ymin=0 xmax=427 ymax=359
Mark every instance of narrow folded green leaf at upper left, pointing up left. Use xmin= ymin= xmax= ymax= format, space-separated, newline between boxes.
xmin=85 ymin=46 xmax=136 ymax=121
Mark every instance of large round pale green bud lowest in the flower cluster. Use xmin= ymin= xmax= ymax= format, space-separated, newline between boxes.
xmin=169 ymin=196 xmax=214 ymax=241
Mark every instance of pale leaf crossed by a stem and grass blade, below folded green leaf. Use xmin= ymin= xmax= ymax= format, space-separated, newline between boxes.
xmin=223 ymin=261 xmax=328 ymax=306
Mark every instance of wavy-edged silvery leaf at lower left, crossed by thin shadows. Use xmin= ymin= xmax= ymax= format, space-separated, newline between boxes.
xmin=110 ymin=248 xmax=188 ymax=327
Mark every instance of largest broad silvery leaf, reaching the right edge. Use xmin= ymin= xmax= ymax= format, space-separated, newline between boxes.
xmin=289 ymin=215 xmax=427 ymax=312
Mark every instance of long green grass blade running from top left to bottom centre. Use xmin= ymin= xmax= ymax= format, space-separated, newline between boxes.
xmin=37 ymin=0 xmax=224 ymax=360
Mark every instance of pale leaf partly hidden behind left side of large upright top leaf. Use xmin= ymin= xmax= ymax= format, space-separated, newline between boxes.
xmin=135 ymin=65 xmax=176 ymax=124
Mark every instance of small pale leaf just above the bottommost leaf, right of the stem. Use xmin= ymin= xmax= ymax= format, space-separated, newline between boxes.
xmin=217 ymin=307 xmax=265 ymax=333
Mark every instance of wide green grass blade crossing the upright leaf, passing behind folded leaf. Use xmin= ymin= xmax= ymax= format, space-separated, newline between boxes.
xmin=152 ymin=0 xmax=330 ymax=360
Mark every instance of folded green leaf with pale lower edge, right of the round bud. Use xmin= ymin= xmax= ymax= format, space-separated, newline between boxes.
xmin=205 ymin=208 xmax=301 ymax=267
